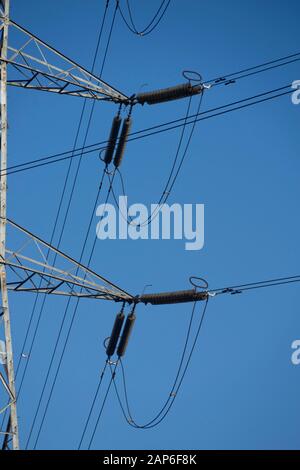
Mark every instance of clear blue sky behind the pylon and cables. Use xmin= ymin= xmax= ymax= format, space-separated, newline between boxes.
xmin=4 ymin=0 xmax=300 ymax=449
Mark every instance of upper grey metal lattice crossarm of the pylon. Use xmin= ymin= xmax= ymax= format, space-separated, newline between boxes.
xmin=0 ymin=15 xmax=128 ymax=103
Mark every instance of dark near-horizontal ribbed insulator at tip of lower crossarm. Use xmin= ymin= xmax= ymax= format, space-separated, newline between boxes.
xmin=139 ymin=290 xmax=208 ymax=305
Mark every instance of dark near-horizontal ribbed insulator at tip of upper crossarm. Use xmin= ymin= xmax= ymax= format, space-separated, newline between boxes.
xmin=136 ymin=83 xmax=203 ymax=104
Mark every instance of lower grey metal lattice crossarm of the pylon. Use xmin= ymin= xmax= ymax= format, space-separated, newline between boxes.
xmin=0 ymin=219 xmax=133 ymax=302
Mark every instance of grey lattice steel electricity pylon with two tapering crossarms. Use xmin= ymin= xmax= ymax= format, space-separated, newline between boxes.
xmin=0 ymin=0 xmax=128 ymax=450
